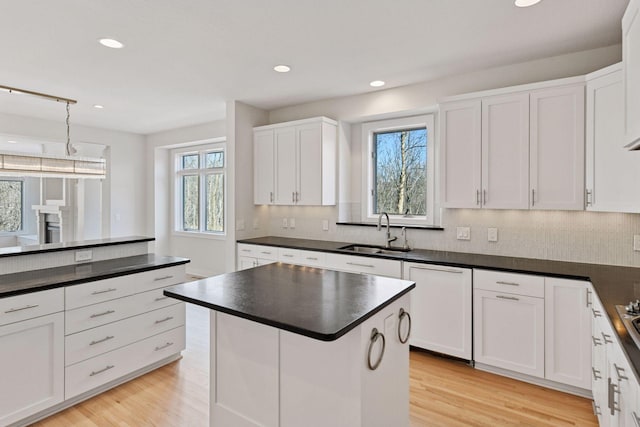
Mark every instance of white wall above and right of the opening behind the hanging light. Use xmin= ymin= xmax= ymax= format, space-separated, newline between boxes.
xmin=0 ymin=113 xmax=147 ymax=237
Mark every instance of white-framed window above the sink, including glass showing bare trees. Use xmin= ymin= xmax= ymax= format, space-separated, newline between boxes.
xmin=363 ymin=115 xmax=435 ymax=225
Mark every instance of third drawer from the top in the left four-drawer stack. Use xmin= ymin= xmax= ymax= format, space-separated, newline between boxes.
xmin=65 ymin=303 xmax=185 ymax=366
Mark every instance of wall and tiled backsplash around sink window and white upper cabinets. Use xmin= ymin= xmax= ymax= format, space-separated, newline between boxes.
xmin=250 ymin=45 xmax=640 ymax=266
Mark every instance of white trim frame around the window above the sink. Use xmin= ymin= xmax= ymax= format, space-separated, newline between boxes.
xmin=360 ymin=114 xmax=437 ymax=226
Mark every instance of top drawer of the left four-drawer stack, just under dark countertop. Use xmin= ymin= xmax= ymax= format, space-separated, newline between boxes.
xmin=65 ymin=265 xmax=185 ymax=310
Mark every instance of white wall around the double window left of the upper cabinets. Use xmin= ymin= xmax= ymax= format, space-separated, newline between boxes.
xmin=146 ymin=120 xmax=229 ymax=276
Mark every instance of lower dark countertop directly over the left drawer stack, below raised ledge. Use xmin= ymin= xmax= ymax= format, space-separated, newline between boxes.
xmin=0 ymin=254 xmax=189 ymax=298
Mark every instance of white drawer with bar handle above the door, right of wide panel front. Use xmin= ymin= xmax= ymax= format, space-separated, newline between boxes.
xmin=473 ymin=269 xmax=544 ymax=298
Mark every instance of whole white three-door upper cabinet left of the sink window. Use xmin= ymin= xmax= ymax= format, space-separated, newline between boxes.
xmin=253 ymin=117 xmax=337 ymax=206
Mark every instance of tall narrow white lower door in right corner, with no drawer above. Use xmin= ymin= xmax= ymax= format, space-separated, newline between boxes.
xmin=544 ymin=277 xmax=591 ymax=390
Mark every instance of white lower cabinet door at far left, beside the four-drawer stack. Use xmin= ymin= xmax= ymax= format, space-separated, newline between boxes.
xmin=0 ymin=310 xmax=64 ymax=426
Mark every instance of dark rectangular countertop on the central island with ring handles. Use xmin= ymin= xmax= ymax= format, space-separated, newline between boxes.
xmin=164 ymin=263 xmax=415 ymax=341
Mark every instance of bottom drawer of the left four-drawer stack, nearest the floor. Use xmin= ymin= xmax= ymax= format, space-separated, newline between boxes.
xmin=65 ymin=326 xmax=185 ymax=399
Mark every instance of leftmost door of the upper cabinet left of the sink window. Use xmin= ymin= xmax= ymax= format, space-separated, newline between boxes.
xmin=253 ymin=129 xmax=275 ymax=205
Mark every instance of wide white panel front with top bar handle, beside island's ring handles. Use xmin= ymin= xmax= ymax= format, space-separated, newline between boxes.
xmin=403 ymin=263 xmax=472 ymax=360
